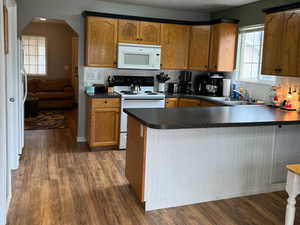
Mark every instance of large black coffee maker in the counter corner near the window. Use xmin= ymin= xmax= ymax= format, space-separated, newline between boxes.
xmin=194 ymin=74 xmax=224 ymax=97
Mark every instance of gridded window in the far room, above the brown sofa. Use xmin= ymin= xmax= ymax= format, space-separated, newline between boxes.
xmin=22 ymin=36 xmax=47 ymax=76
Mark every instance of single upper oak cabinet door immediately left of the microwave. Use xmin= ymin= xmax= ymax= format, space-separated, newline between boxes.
xmin=85 ymin=17 xmax=118 ymax=67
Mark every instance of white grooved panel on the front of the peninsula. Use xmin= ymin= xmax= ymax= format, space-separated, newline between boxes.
xmin=145 ymin=126 xmax=300 ymax=210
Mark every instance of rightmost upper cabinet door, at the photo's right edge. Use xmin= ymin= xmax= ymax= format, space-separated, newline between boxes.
xmin=279 ymin=11 xmax=300 ymax=76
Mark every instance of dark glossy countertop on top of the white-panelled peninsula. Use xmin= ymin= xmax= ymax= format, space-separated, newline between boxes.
xmin=124 ymin=105 xmax=300 ymax=129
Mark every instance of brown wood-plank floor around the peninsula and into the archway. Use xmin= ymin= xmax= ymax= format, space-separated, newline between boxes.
xmin=8 ymin=124 xmax=300 ymax=225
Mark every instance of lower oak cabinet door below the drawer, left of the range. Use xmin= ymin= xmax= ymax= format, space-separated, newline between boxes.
xmin=90 ymin=108 xmax=120 ymax=147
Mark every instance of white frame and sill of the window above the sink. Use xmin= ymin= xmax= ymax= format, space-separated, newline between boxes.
xmin=234 ymin=24 xmax=277 ymax=85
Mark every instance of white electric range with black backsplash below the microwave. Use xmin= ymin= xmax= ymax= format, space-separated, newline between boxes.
xmin=114 ymin=76 xmax=165 ymax=149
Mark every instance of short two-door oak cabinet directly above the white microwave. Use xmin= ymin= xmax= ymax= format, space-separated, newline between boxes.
xmin=118 ymin=20 xmax=161 ymax=45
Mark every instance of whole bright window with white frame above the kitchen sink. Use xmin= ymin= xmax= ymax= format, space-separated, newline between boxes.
xmin=237 ymin=26 xmax=276 ymax=81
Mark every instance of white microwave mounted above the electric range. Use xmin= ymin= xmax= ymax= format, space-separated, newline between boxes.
xmin=118 ymin=43 xmax=161 ymax=70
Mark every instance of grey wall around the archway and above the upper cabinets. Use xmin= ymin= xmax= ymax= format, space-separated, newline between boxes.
xmin=18 ymin=0 xmax=210 ymax=137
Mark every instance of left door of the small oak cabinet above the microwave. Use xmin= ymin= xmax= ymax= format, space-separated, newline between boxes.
xmin=118 ymin=20 xmax=140 ymax=43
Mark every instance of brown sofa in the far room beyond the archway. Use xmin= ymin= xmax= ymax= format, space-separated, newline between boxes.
xmin=28 ymin=79 xmax=74 ymax=109
